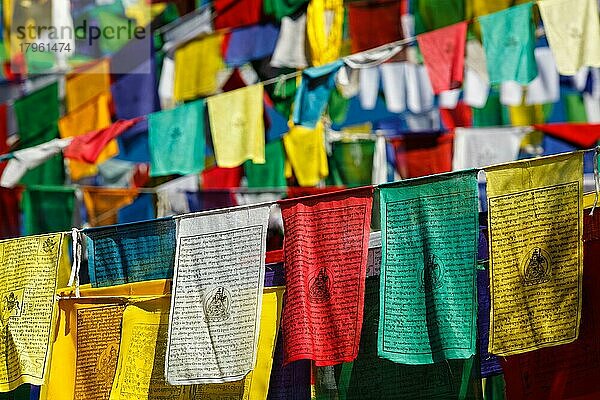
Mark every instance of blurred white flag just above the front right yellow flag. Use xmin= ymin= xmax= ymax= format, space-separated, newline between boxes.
xmin=452 ymin=127 xmax=525 ymax=171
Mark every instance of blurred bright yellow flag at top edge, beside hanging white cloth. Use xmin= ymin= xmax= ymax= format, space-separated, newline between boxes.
xmin=306 ymin=0 xmax=344 ymax=66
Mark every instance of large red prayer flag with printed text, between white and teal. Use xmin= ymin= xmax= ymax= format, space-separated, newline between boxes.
xmin=279 ymin=187 xmax=373 ymax=366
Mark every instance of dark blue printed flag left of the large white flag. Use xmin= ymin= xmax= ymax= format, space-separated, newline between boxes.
xmin=83 ymin=218 xmax=175 ymax=287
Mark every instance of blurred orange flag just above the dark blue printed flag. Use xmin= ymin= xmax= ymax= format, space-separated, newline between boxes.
xmin=83 ymin=186 xmax=138 ymax=226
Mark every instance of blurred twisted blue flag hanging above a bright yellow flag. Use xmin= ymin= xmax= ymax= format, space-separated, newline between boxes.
xmin=293 ymin=61 xmax=344 ymax=128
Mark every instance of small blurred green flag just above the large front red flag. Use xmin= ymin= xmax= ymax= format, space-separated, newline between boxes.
xmin=332 ymin=140 xmax=375 ymax=187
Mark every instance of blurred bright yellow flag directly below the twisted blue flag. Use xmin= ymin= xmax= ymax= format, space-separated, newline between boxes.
xmin=283 ymin=122 xmax=329 ymax=186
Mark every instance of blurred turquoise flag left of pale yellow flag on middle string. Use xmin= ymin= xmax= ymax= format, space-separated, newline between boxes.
xmin=148 ymin=100 xmax=205 ymax=176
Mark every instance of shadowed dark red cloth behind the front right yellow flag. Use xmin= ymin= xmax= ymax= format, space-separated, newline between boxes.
xmin=501 ymin=210 xmax=600 ymax=400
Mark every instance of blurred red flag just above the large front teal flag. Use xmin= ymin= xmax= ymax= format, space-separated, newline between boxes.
xmin=390 ymin=134 xmax=454 ymax=179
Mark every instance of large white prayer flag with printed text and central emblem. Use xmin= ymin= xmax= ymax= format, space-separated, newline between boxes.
xmin=165 ymin=205 xmax=269 ymax=385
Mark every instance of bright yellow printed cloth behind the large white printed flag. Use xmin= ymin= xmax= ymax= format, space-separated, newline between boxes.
xmin=110 ymin=287 xmax=284 ymax=400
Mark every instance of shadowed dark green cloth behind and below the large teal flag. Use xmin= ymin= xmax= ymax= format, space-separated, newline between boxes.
xmin=338 ymin=276 xmax=481 ymax=400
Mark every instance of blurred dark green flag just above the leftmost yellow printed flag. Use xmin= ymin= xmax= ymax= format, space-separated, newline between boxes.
xmin=21 ymin=185 xmax=75 ymax=235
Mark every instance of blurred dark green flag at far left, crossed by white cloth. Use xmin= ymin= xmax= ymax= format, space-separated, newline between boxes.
xmin=14 ymin=83 xmax=65 ymax=185
